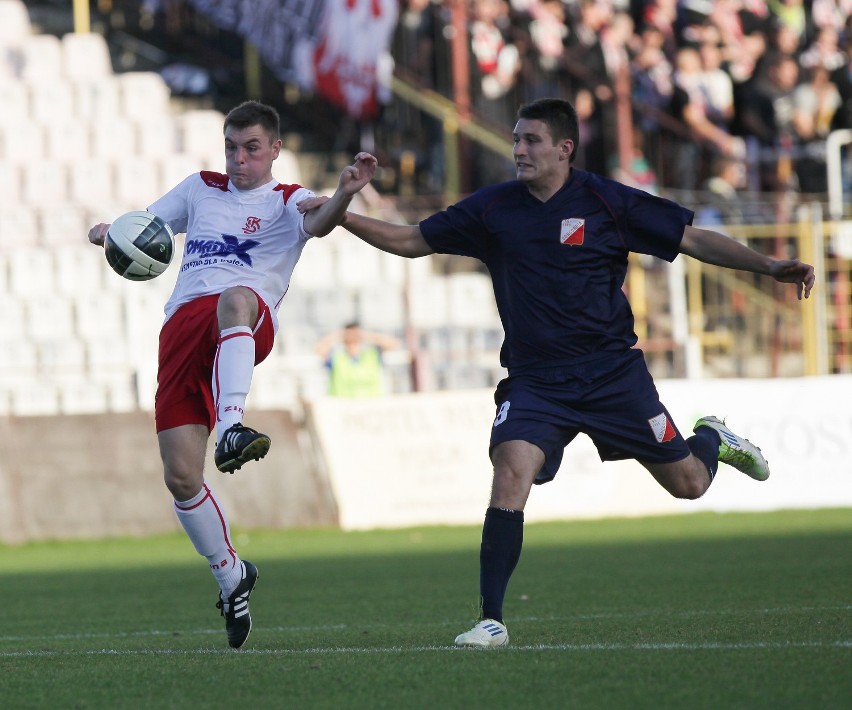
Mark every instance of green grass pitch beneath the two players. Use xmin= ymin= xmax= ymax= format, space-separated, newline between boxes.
xmin=0 ymin=509 xmax=852 ymax=710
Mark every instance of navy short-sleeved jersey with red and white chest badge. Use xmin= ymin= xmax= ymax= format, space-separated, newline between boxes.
xmin=420 ymin=169 xmax=693 ymax=372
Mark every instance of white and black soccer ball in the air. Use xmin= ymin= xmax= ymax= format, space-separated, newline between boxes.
xmin=104 ymin=211 xmax=175 ymax=281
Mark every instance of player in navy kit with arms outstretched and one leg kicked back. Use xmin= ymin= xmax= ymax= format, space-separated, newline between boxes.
xmin=301 ymin=99 xmax=814 ymax=647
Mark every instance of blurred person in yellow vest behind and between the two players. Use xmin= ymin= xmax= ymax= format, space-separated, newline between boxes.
xmin=316 ymin=322 xmax=400 ymax=398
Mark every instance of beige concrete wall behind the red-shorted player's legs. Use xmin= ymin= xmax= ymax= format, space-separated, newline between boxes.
xmin=0 ymin=411 xmax=338 ymax=543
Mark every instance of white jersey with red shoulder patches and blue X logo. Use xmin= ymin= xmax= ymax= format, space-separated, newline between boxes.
xmin=148 ymin=171 xmax=314 ymax=330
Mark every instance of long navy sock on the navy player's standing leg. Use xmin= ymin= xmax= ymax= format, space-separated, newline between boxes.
xmin=479 ymin=508 xmax=524 ymax=622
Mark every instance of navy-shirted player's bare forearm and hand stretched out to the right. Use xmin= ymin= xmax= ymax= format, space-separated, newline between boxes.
xmin=680 ymin=226 xmax=815 ymax=300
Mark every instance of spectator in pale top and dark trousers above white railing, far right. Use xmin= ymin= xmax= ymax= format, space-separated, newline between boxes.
xmin=792 ymin=64 xmax=841 ymax=193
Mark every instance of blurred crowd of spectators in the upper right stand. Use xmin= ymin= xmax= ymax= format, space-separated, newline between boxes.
xmin=393 ymin=0 xmax=852 ymax=203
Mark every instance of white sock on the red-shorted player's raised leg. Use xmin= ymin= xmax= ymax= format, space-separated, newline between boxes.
xmin=213 ymin=326 xmax=255 ymax=444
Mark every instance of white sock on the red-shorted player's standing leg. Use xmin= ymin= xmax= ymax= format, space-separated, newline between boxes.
xmin=175 ymin=483 xmax=243 ymax=597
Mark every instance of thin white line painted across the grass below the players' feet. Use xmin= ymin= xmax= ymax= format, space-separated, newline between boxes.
xmin=0 ymin=640 xmax=852 ymax=658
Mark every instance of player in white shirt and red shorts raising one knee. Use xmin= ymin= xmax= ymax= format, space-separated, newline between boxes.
xmin=89 ymin=101 xmax=376 ymax=648
